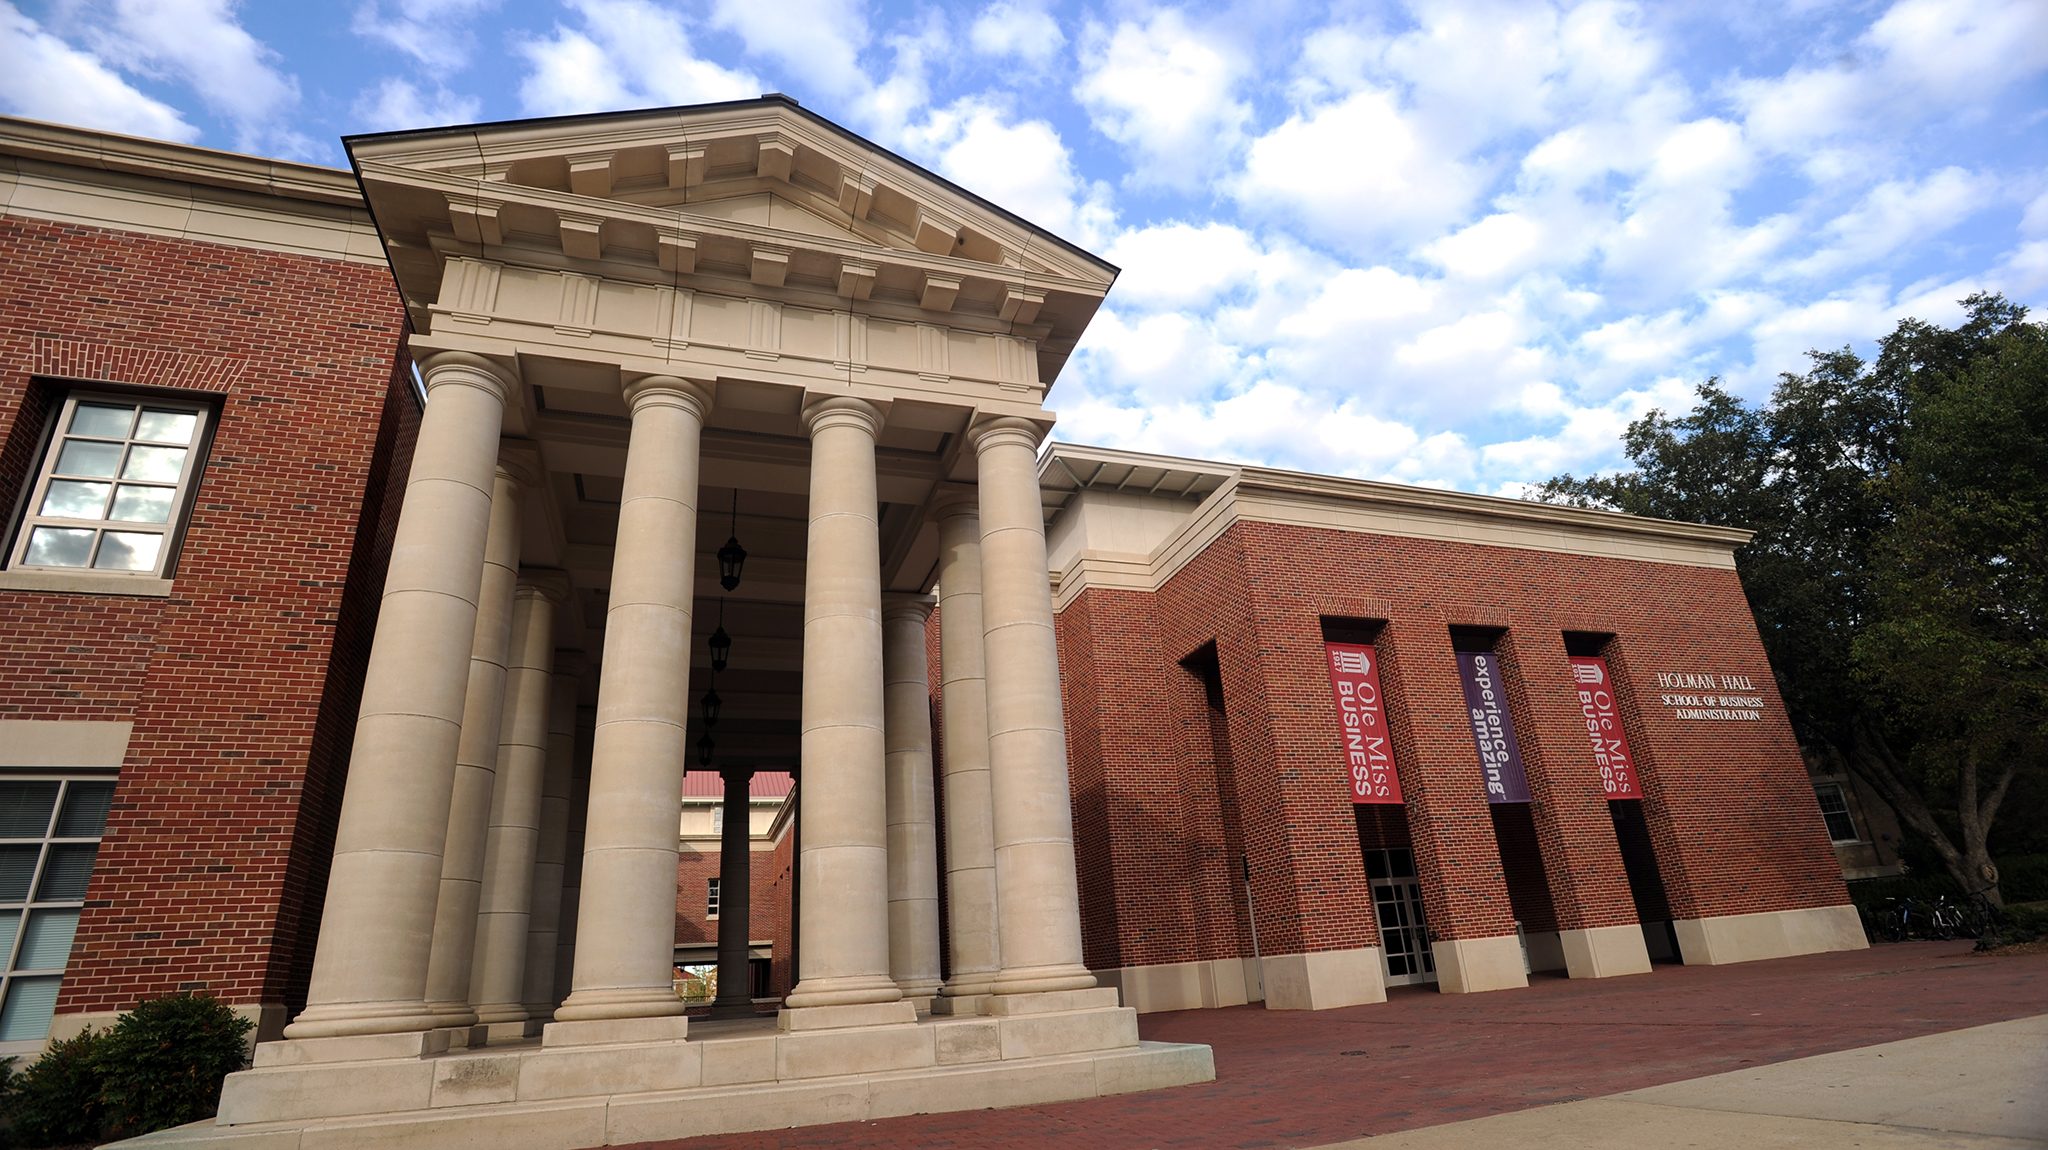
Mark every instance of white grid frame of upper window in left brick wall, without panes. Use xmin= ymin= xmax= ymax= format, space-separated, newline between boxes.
xmin=6 ymin=387 xmax=213 ymax=581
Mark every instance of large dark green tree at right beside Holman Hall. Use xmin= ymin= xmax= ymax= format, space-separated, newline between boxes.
xmin=1536 ymin=295 xmax=2048 ymax=898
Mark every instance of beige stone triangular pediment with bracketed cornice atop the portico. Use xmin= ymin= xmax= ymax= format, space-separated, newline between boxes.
xmin=346 ymin=96 xmax=1116 ymax=379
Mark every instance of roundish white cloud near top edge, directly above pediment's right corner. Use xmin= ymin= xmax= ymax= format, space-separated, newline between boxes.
xmin=1073 ymin=8 xmax=1251 ymax=186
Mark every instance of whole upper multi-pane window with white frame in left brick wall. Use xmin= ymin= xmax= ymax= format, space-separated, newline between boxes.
xmin=8 ymin=391 xmax=207 ymax=575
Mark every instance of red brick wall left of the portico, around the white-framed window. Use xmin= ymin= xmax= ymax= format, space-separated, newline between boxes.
xmin=0 ymin=217 xmax=412 ymax=1013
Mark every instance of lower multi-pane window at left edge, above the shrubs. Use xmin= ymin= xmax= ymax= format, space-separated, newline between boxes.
xmin=0 ymin=776 xmax=115 ymax=1050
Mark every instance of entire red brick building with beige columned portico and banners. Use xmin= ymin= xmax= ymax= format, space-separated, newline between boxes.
xmin=0 ymin=98 xmax=1862 ymax=1146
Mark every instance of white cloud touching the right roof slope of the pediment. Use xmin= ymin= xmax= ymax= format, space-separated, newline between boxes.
xmin=905 ymin=98 xmax=1112 ymax=246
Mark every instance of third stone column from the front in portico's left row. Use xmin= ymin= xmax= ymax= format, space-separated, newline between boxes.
xmin=469 ymin=571 xmax=569 ymax=1037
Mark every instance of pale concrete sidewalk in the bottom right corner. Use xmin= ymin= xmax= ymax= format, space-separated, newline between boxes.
xmin=1331 ymin=1015 xmax=2048 ymax=1150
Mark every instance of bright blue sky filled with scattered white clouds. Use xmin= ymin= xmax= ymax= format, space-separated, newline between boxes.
xmin=0 ymin=0 xmax=2048 ymax=493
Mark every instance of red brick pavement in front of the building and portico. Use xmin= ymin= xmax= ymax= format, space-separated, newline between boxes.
xmin=639 ymin=941 xmax=2048 ymax=1150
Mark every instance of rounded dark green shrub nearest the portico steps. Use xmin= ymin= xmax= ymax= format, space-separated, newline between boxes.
xmin=98 ymin=994 xmax=254 ymax=1138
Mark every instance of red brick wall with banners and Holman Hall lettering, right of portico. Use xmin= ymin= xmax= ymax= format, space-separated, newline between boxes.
xmin=1059 ymin=524 xmax=1847 ymax=966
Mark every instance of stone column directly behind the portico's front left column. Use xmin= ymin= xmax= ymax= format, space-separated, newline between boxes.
xmin=426 ymin=456 xmax=539 ymax=1027
